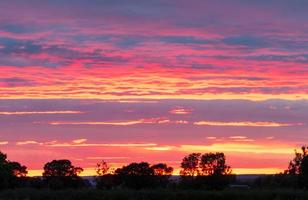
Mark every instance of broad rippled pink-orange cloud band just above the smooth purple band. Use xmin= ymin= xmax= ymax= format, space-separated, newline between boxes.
xmin=0 ymin=65 xmax=308 ymax=101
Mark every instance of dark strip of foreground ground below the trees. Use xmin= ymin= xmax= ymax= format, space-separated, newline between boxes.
xmin=0 ymin=189 xmax=308 ymax=200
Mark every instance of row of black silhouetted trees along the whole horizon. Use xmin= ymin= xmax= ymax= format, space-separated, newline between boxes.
xmin=0 ymin=147 xmax=308 ymax=190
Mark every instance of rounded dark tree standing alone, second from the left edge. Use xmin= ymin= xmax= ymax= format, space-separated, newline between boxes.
xmin=43 ymin=160 xmax=84 ymax=189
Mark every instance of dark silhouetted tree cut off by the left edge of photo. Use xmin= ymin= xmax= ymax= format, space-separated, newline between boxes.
xmin=0 ymin=152 xmax=28 ymax=189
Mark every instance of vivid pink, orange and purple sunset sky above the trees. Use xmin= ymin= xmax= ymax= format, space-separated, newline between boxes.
xmin=0 ymin=0 xmax=308 ymax=175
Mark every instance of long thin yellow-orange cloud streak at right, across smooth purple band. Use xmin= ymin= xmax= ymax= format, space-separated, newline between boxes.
xmin=194 ymin=121 xmax=302 ymax=127
